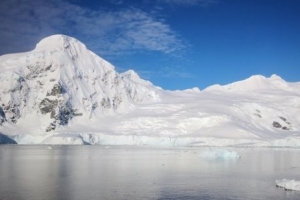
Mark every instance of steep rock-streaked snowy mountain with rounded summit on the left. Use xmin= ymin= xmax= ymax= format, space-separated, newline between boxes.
xmin=0 ymin=35 xmax=159 ymax=132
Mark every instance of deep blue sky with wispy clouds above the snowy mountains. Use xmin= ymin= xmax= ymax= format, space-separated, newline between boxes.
xmin=0 ymin=0 xmax=300 ymax=90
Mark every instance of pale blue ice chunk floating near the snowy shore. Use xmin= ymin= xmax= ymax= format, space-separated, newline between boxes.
xmin=199 ymin=149 xmax=241 ymax=159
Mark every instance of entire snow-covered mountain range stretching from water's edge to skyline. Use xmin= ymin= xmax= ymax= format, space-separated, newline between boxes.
xmin=0 ymin=35 xmax=300 ymax=147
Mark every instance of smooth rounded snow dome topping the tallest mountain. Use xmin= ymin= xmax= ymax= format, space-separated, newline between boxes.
xmin=35 ymin=34 xmax=86 ymax=50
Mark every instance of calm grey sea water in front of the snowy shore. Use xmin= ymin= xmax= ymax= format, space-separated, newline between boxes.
xmin=0 ymin=146 xmax=300 ymax=200
